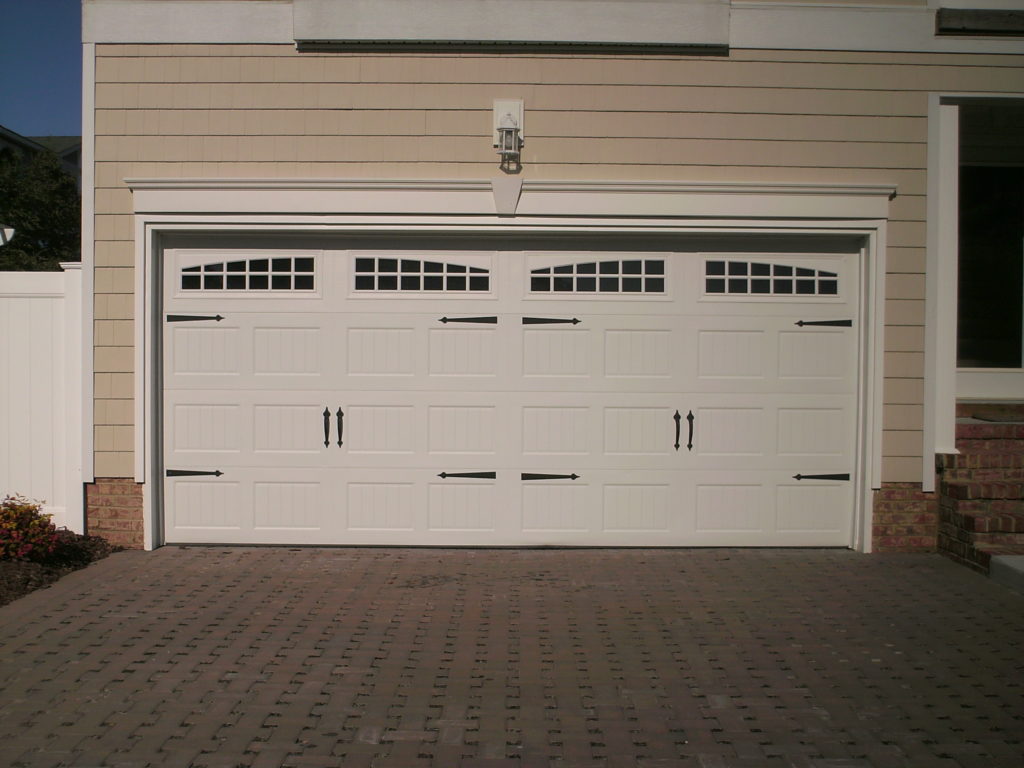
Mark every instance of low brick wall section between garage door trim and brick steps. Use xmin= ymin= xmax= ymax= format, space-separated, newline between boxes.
xmin=872 ymin=482 xmax=939 ymax=552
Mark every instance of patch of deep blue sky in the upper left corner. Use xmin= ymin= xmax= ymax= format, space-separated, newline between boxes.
xmin=0 ymin=0 xmax=82 ymax=136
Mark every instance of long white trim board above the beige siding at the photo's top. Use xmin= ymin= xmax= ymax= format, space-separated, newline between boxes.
xmin=82 ymin=0 xmax=1024 ymax=54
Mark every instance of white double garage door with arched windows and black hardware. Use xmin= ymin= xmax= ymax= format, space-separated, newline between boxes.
xmin=163 ymin=243 xmax=858 ymax=546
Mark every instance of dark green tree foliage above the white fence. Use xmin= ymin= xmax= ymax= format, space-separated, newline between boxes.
xmin=0 ymin=152 xmax=81 ymax=271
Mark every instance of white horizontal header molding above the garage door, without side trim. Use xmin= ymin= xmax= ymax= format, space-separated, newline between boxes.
xmin=125 ymin=178 xmax=896 ymax=220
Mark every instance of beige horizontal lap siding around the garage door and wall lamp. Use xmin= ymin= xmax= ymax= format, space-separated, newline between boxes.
xmin=95 ymin=45 xmax=1024 ymax=481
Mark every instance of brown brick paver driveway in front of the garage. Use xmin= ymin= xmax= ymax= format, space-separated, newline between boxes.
xmin=0 ymin=547 xmax=1024 ymax=768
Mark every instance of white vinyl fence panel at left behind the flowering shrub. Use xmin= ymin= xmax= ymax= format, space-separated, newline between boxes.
xmin=0 ymin=263 xmax=85 ymax=532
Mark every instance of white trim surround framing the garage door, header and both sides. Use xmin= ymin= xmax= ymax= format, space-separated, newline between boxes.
xmin=128 ymin=179 xmax=893 ymax=551
